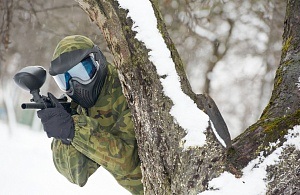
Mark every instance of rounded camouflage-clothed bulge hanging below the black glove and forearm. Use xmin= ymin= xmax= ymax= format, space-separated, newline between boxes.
xmin=51 ymin=139 xmax=99 ymax=186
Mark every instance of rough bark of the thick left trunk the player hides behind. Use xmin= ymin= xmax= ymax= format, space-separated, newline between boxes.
xmin=78 ymin=0 xmax=226 ymax=194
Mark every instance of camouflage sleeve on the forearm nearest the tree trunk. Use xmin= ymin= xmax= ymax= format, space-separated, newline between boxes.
xmin=72 ymin=111 xmax=139 ymax=176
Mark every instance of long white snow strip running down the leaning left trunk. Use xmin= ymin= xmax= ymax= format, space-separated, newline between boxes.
xmin=118 ymin=0 xmax=224 ymax=149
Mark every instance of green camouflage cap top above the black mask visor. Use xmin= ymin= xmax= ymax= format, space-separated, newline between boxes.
xmin=52 ymin=35 xmax=94 ymax=60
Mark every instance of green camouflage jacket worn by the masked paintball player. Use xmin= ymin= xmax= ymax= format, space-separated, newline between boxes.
xmin=51 ymin=65 xmax=143 ymax=194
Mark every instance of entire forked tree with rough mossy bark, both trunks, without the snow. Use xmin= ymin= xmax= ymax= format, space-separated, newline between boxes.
xmin=77 ymin=0 xmax=300 ymax=194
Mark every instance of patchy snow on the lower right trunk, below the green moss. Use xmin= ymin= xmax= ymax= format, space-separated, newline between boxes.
xmin=199 ymin=126 xmax=300 ymax=195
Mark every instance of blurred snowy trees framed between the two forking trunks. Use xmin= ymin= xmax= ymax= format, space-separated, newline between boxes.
xmin=159 ymin=0 xmax=286 ymax=137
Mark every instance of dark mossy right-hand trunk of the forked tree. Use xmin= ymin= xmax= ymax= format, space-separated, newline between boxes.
xmin=228 ymin=0 xmax=300 ymax=194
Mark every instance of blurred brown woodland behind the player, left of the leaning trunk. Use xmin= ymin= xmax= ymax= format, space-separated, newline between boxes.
xmin=0 ymin=0 xmax=106 ymax=129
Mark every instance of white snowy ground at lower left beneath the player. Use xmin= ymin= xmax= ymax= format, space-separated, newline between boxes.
xmin=0 ymin=121 xmax=130 ymax=195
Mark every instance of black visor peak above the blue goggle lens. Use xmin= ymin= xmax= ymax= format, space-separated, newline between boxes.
xmin=49 ymin=45 xmax=105 ymax=76
